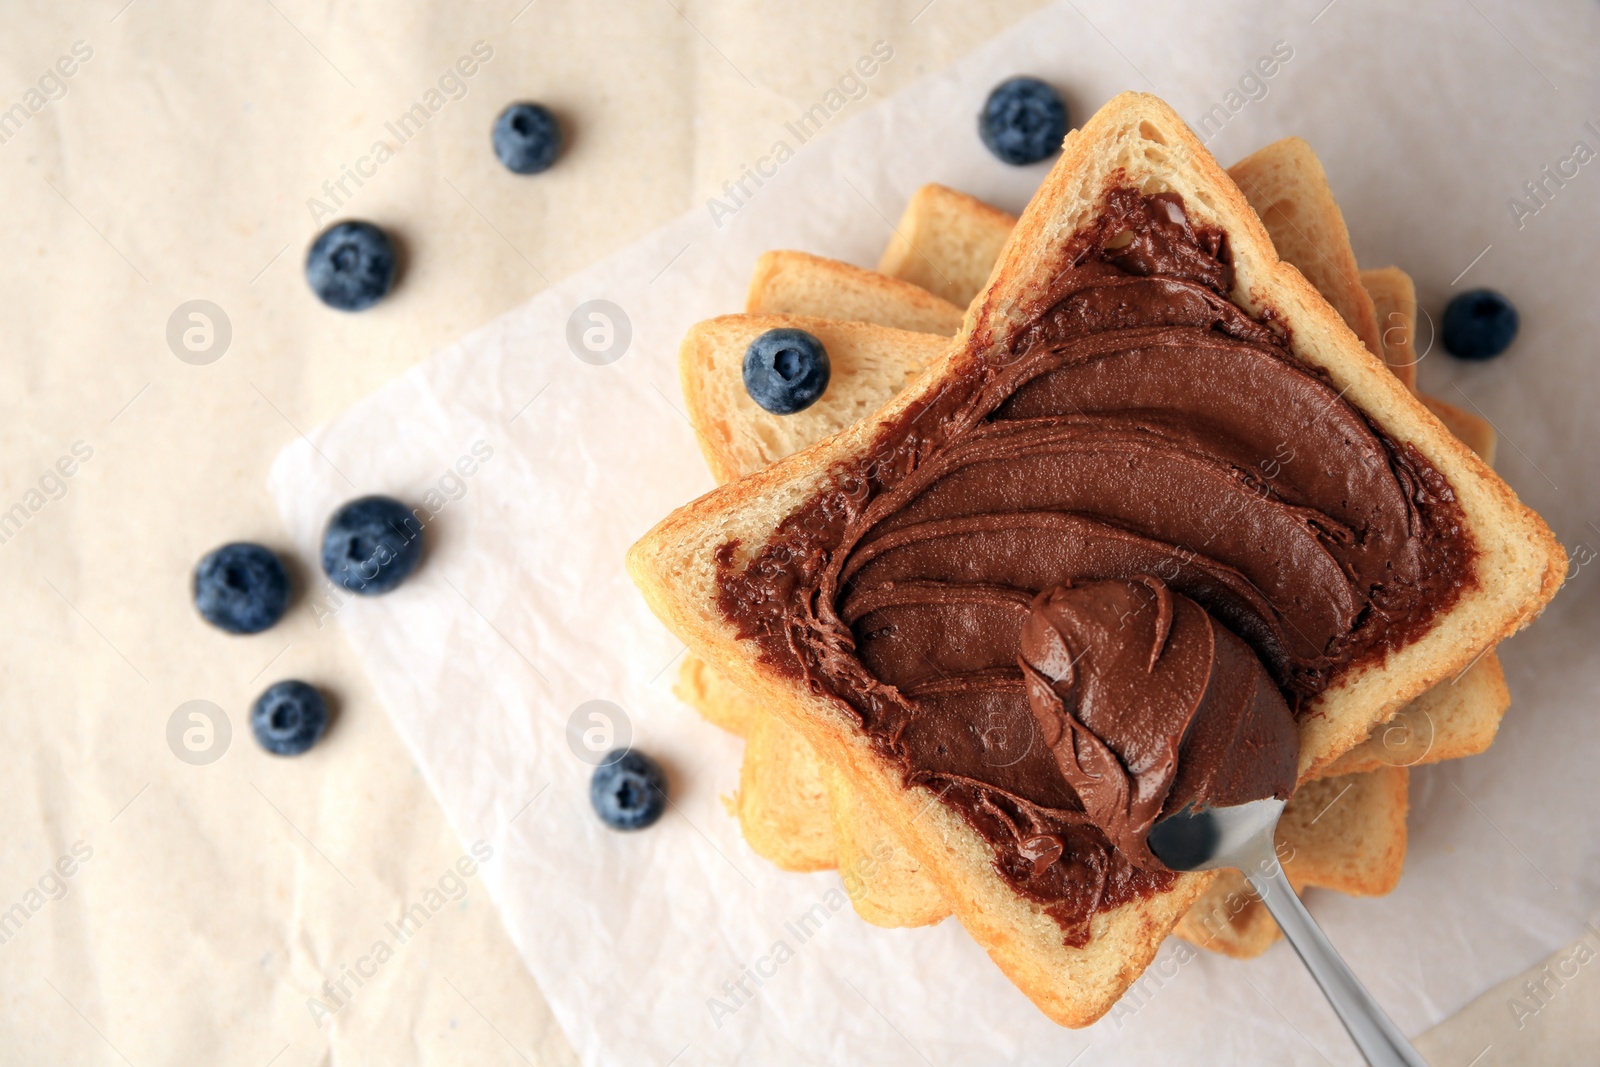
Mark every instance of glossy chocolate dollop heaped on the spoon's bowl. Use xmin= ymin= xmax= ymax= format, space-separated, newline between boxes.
xmin=1018 ymin=574 xmax=1299 ymax=870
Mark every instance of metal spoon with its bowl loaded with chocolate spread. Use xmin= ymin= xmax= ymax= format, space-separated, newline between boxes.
xmin=1018 ymin=574 xmax=1426 ymax=1067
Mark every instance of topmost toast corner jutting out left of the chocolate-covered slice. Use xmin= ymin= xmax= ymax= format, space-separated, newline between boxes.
xmin=878 ymin=184 xmax=1016 ymax=310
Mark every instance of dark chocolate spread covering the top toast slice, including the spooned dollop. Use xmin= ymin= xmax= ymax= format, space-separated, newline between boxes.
xmin=717 ymin=189 xmax=1472 ymax=945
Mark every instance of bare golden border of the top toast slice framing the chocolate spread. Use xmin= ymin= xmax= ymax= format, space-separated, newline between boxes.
xmin=629 ymin=94 xmax=1563 ymax=1025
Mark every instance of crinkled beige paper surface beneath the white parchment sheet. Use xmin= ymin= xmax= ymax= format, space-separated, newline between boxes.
xmin=0 ymin=0 xmax=1600 ymax=1065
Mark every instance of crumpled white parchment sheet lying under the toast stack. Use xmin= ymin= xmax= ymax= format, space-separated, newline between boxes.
xmin=270 ymin=0 xmax=1600 ymax=1067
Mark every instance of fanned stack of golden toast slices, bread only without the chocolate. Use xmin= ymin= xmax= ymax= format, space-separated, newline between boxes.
xmin=630 ymin=94 xmax=1563 ymax=1025
